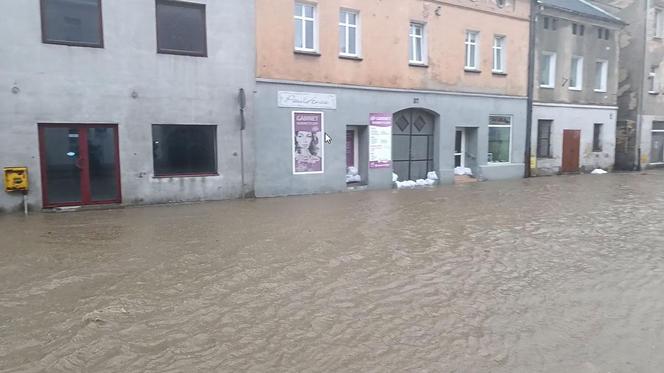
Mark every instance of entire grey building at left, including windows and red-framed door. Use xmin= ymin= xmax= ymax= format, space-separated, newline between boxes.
xmin=0 ymin=0 xmax=255 ymax=210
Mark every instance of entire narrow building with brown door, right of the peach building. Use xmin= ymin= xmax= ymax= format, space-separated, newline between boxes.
xmin=531 ymin=0 xmax=623 ymax=175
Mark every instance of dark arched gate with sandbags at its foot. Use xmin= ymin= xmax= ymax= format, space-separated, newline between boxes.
xmin=392 ymin=109 xmax=434 ymax=181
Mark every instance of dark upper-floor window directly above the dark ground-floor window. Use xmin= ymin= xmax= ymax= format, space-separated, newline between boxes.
xmin=157 ymin=0 xmax=207 ymax=57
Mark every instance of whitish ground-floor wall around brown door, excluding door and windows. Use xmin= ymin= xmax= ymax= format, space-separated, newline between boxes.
xmin=532 ymin=104 xmax=618 ymax=175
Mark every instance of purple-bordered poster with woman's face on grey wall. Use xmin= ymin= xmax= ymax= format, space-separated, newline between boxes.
xmin=293 ymin=111 xmax=324 ymax=174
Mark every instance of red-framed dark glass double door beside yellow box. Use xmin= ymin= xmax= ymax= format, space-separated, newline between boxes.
xmin=39 ymin=124 xmax=122 ymax=208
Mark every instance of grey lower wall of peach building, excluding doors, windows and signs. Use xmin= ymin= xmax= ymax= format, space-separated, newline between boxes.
xmin=255 ymin=80 xmax=526 ymax=197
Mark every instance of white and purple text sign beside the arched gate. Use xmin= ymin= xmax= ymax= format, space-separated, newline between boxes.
xmin=369 ymin=113 xmax=392 ymax=168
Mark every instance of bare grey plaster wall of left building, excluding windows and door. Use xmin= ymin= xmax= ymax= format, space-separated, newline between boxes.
xmin=0 ymin=0 xmax=255 ymax=209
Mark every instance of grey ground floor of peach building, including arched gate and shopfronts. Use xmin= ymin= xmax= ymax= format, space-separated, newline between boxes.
xmin=254 ymin=80 xmax=526 ymax=197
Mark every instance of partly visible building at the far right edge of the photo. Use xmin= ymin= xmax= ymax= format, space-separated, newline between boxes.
xmin=595 ymin=0 xmax=664 ymax=170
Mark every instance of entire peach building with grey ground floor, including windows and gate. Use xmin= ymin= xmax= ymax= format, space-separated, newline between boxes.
xmin=255 ymin=0 xmax=530 ymax=196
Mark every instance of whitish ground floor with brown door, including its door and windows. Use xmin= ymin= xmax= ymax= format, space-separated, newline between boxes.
xmin=532 ymin=103 xmax=618 ymax=176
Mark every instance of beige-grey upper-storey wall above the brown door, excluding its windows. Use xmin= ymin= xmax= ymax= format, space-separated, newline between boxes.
xmin=534 ymin=9 xmax=620 ymax=106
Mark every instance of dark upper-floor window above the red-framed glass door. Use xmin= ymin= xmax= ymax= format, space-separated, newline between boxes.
xmin=41 ymin=0 xmax=104 ymax=48
